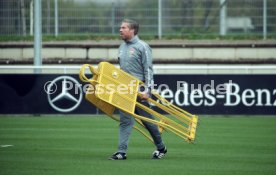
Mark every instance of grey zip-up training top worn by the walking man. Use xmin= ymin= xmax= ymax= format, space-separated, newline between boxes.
xmin=118 ymin=35 xmax=153 ymax=91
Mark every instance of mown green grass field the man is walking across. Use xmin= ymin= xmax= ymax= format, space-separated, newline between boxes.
xmin=0 ymin=116 xmax=276 ymax=175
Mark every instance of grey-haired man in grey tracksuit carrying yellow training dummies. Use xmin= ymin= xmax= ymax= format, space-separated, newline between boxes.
xmin=109 ymin=19 xmax=167 ymax=160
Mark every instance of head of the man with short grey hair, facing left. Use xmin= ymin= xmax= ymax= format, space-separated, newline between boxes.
xmin=120 ymin=19 xmax=139 ymax=41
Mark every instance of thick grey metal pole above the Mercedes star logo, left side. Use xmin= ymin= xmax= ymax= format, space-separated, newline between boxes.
xmin=34 ymin=0 xmax=42 ymax=73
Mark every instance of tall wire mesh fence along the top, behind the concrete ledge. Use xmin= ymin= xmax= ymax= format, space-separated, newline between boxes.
xmin=0 ymin=0 xmax=276 ymax=38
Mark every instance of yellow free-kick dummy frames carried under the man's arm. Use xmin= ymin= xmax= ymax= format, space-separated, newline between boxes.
xmin=79 ymin=62 xmax=198 ymax=142
